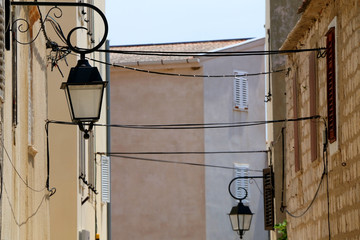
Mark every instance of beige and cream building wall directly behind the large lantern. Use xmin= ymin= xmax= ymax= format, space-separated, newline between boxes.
xmin=48 ymin=1 xmax=107 ymax=240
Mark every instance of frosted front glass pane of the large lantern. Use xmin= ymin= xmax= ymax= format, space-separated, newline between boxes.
xmin=68 ymin=84 xmax=104 ymax=121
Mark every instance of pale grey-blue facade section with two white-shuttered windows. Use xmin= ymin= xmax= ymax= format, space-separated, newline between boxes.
xmin=200 ymin=38 xmax=268 ymax=240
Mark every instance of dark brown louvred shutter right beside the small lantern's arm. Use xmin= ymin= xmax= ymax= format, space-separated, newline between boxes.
xmin=263 ymin=168 xmax=274 ymax=230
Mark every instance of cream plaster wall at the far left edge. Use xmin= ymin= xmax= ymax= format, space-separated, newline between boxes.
xmin=0 ymin=3 xmax=50 ymax=240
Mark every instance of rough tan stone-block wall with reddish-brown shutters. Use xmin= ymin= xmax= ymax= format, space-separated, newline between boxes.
xmin=285 ymin=0 xmax=360 ymax=240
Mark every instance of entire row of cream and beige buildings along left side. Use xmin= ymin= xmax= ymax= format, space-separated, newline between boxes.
xmin=0 ymin=1 xmax=107 ymax=240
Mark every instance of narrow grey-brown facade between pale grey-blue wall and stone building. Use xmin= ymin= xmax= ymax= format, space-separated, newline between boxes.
xmin=265 ymin=0 xmax=301 ymax=239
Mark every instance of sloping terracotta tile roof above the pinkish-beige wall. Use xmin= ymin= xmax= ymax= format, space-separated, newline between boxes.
xmin=110 ymin=38 xmax=248 ymax=63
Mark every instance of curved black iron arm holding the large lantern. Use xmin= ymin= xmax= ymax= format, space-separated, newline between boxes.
xmin=5 ymin=0 xmax=109 ymax=55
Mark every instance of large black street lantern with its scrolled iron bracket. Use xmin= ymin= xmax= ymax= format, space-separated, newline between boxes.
xmin=5 ymin=0 xmax=109 ymax=139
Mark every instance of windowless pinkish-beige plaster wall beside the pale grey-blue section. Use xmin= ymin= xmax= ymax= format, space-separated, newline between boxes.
xmin=111 ymin=64 xmax=205 ymax=240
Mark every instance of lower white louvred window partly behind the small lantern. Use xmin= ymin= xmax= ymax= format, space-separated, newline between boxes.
xmin=234 ymin=163 xmax=250 ymax=204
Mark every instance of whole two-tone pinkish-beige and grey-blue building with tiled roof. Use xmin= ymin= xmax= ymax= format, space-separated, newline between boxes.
xmin=110 ymin=39 xmax=268 ymax=240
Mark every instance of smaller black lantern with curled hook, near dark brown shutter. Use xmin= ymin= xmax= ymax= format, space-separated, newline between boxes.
xmin=228 ymin=177 xmax=254 ymax=239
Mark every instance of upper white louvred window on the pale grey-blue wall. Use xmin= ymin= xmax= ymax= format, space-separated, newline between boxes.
xmin=233 ymin=71 xmax=249 ymax=111
